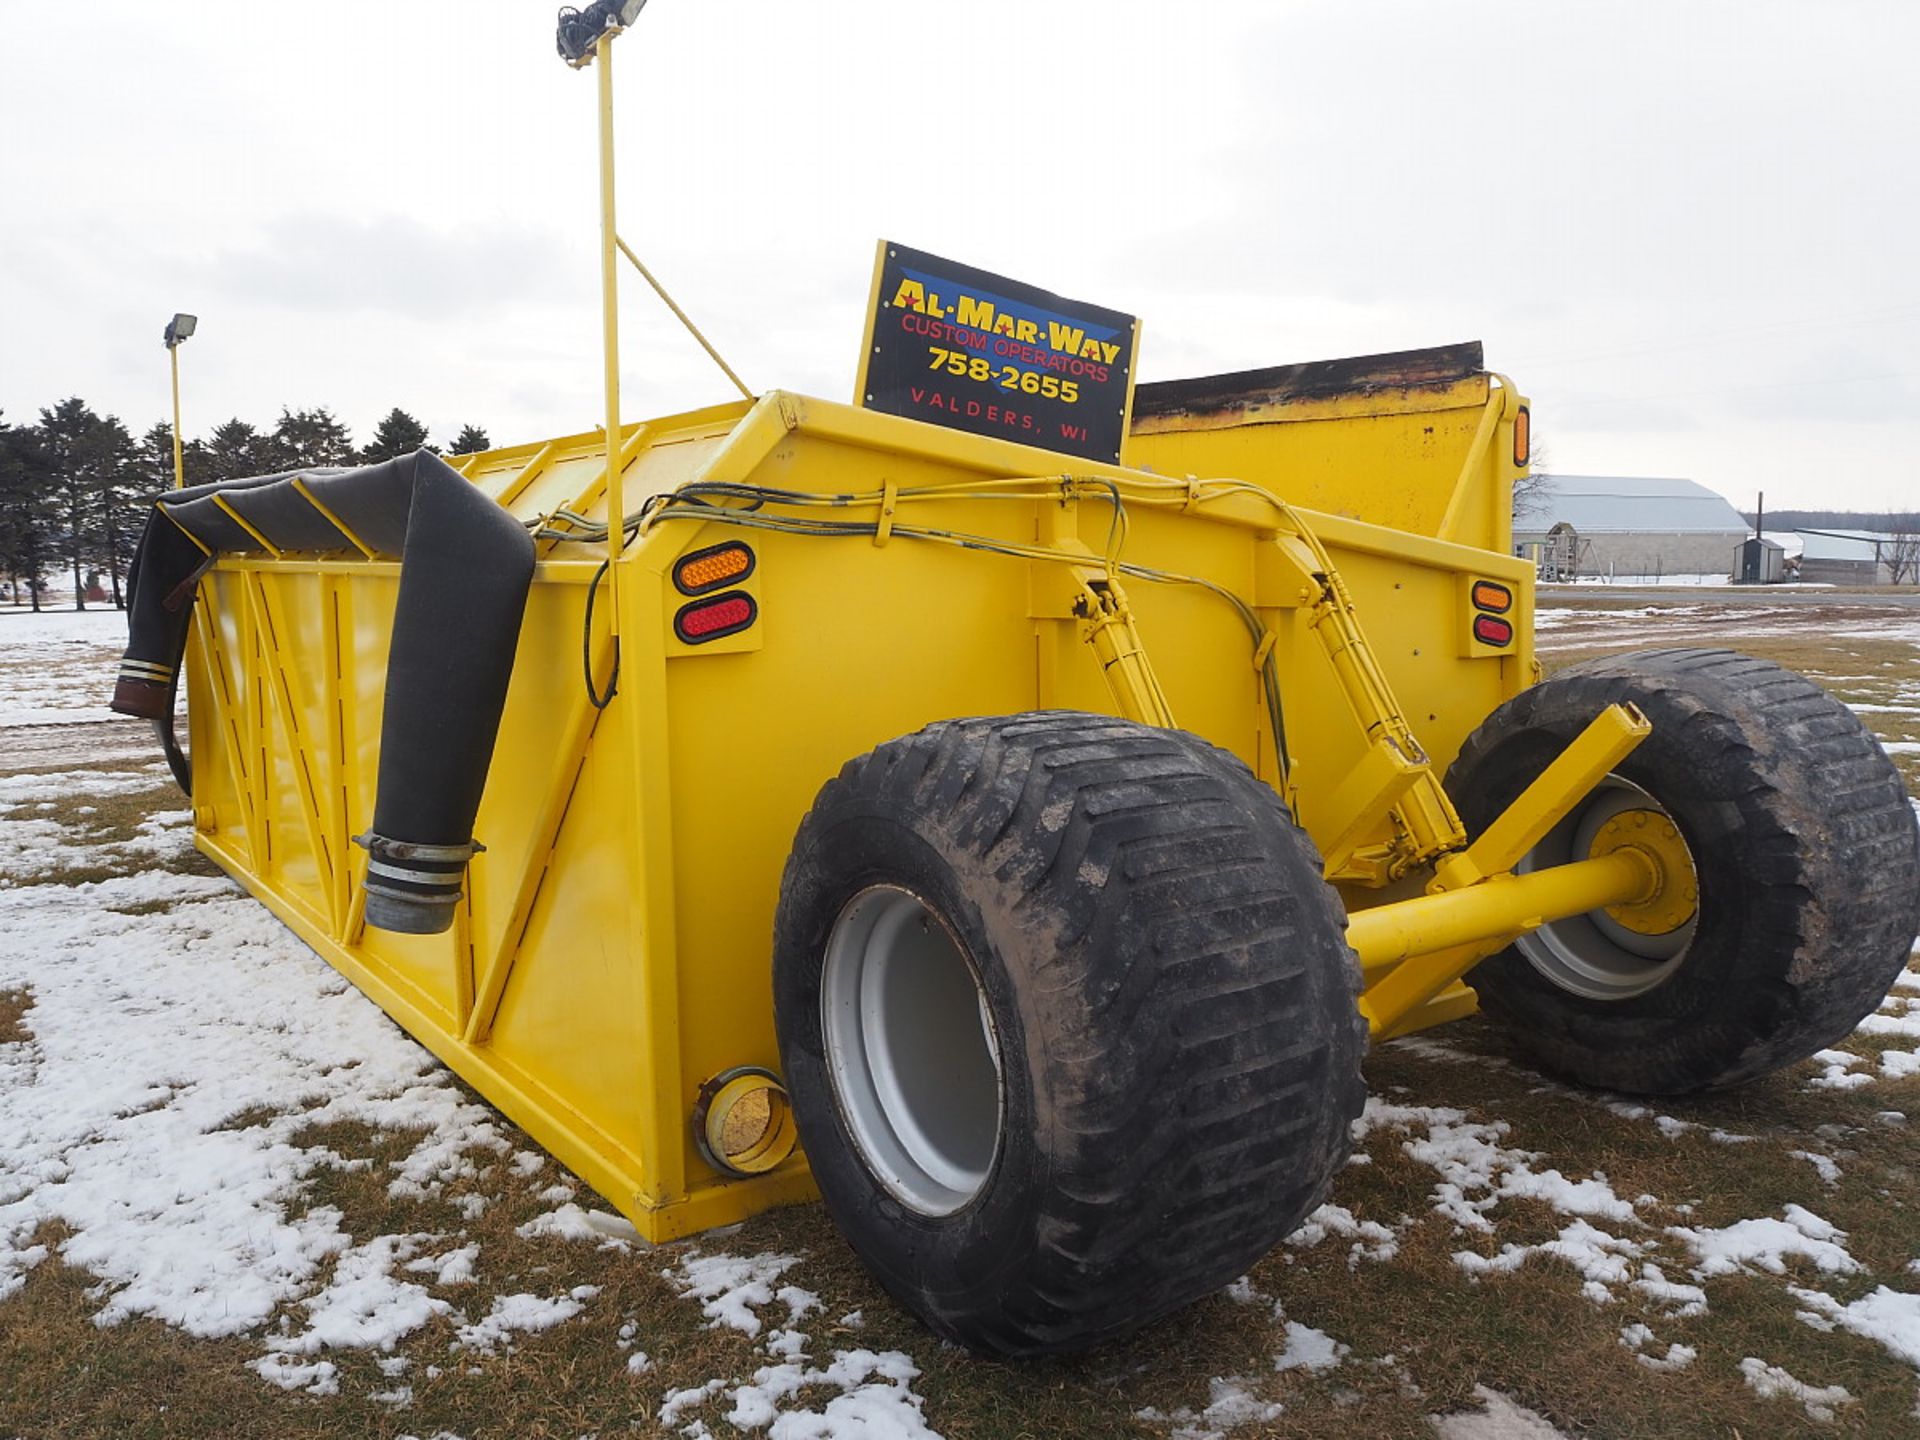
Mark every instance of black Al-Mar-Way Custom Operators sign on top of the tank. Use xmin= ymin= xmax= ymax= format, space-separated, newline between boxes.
xmin=858 ymin=240 xmax=1139 ymax=465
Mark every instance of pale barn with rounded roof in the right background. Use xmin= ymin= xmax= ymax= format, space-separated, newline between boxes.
xmin=1513 ymin=474 xmax=1751 ymax=580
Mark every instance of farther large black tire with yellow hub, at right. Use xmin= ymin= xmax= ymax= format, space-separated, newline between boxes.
xmin=1448 ymin=649 xmax=1920 ymax=1094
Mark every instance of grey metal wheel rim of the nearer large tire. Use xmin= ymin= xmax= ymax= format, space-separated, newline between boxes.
xmin=820 ymin=885 xmax=1006 ymax=1215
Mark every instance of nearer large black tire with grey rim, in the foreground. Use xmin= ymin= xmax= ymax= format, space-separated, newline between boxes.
xmin=774 ymin=710 xmax=1365 ymax=1356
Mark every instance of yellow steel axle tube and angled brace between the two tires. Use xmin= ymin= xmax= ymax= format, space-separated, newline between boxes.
xmin=1346 ymin=705 xmax=1661 ymax=1039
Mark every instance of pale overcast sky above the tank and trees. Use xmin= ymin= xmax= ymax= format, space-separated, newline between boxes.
xmin=0 ymin=0 xmax=1920 ymax=509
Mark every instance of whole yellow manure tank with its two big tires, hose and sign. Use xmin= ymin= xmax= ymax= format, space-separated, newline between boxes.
xmin=101 ymin=11 xmax=1920 ymax=1356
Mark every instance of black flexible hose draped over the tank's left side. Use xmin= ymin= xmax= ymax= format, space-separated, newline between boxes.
xmin=111 ymin=451 xmax=534 ymax=935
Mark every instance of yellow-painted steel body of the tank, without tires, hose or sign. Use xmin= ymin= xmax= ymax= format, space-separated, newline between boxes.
xmin=186 ymin=360 xmax=1647 ymax=1240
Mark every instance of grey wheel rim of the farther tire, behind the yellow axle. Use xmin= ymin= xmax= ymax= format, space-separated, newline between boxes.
xmin=1515 ymin=776 xmax=1699 ymax=1000
